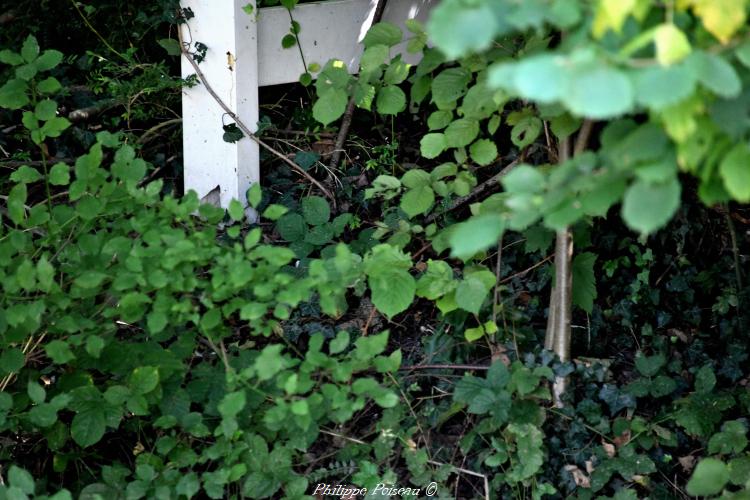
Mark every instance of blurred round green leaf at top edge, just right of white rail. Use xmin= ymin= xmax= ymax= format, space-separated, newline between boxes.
xmin=427 ymin=0 xmax=499 ymax=59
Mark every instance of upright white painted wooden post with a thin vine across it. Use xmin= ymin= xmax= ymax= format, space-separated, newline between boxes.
xmin=182 ymin=0 xmax=260 ymax=207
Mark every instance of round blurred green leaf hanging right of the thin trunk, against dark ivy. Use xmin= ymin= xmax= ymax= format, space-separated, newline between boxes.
xmin=622 ymin=177 xmax=681 ymax=234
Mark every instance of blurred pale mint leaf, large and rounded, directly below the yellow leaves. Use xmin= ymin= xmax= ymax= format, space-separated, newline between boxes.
xmin=563 ymin=64 xmax=634 ymax=120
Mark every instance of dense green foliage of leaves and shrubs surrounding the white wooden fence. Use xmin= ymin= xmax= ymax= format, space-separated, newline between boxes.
xmin=0 ymin=0 xmax=750 ymax=500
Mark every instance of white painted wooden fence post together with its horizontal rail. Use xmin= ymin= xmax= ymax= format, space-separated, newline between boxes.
xmin=182 ymin=0 xmax=437 ymax=207
